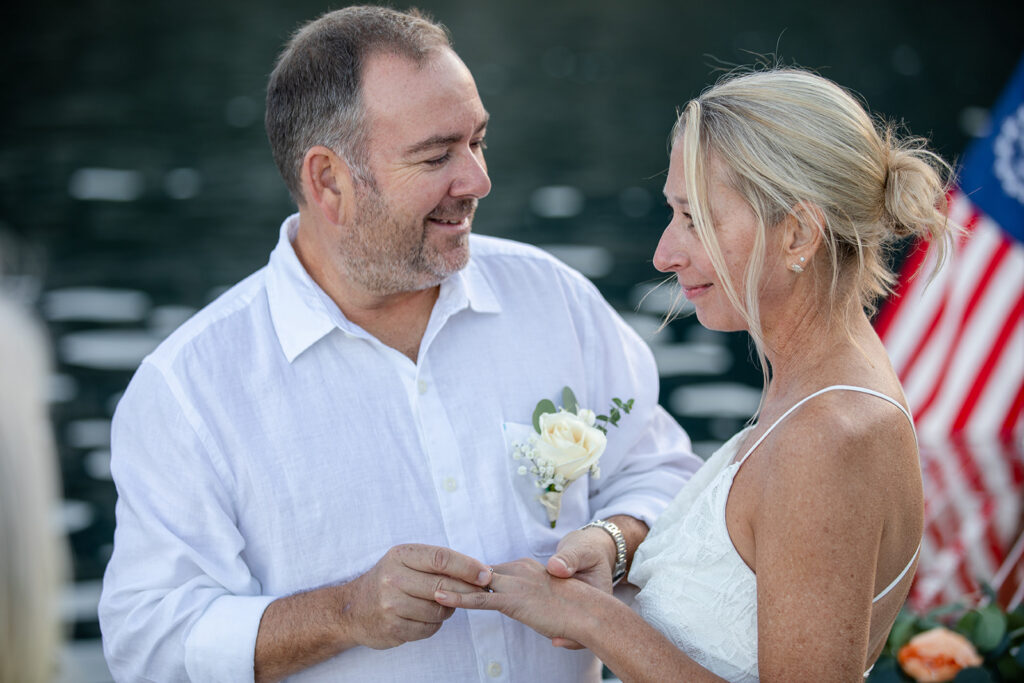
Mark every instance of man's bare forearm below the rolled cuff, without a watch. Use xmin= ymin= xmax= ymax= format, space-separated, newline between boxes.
xmin=254 ymin=585 xmax=358 ymax=683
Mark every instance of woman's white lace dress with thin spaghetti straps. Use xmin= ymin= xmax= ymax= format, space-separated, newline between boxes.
xmin=629 ymin=385 xmax=920 ymax=683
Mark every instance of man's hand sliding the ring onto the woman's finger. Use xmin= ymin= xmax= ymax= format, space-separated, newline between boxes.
xmin=341 ymin=545 xmax=490 ymax=649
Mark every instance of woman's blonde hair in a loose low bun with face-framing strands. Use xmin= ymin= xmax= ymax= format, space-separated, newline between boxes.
xmin=672 ymin=68 xmax=958 ymax=362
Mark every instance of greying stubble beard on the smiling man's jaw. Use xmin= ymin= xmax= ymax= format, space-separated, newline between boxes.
xmin=339 ymin=181 xmax=476 ymax=295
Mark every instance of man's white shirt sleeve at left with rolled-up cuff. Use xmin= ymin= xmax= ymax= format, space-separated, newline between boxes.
xmin=99 ymin=364 xmax=273 ymax=683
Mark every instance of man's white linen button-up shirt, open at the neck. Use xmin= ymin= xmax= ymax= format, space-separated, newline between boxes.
xmin=99 ymin=216 xmax=699 ymax=683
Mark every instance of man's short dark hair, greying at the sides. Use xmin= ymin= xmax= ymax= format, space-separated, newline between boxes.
xmin=264 ymin=6 xmax=452 ymax=206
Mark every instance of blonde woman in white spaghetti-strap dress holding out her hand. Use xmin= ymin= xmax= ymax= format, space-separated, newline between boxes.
xmin=437 ymin=69 xmax=956 ymax=681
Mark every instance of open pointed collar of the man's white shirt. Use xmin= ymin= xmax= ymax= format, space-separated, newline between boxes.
xmin=266 ymin=213 xmax=502 ymax=362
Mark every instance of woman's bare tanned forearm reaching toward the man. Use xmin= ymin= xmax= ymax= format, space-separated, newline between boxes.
xmin=573 ymin=589 xmax=725 ymax=683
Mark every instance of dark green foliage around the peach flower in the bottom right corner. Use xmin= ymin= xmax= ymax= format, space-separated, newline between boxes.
xmin=867 ymin=602 xmax=1024 ymax=683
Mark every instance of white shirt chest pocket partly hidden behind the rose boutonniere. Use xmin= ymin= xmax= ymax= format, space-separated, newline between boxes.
xmin=502 ymin=422 xmax=591 ymax=558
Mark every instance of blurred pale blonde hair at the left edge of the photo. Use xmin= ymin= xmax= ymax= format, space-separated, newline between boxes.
xmin=0 ymin=298 xmax=66 ymax=683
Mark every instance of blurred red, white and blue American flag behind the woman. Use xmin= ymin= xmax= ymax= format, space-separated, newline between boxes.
xmin=874 ymin=54 xmax=1024 ymax=608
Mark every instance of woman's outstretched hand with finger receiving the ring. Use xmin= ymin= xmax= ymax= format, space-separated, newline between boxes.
xmin=434 ymin=559 xmax=600 ymax=644
